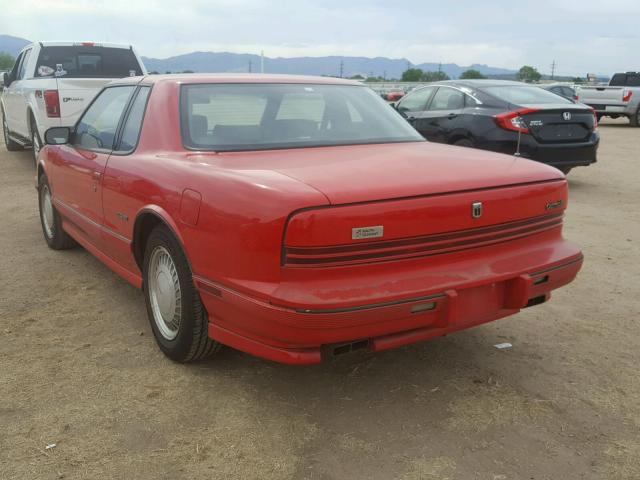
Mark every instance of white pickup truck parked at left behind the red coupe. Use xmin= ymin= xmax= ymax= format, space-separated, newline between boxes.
xmin=0 ymin=42 xmax=146 ymax=158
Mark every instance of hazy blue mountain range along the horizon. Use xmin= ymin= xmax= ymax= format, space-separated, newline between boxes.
xmin=0 ymin=35 xmax=515 ymax=78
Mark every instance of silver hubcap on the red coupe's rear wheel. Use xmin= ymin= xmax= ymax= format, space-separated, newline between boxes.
xmin=147 ymin=247 xmax=182 ymax=340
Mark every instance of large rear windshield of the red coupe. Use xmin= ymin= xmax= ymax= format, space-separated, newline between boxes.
xmin=181 ymin=84 xmax=423 ymax=151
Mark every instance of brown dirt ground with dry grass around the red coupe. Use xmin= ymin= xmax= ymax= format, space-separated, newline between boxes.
xmin=0 ymin=120 xmax=640 ymax=480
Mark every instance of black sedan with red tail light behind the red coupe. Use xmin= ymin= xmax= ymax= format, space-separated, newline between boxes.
xmin=394 ymin=80 xmax=600 ymax=173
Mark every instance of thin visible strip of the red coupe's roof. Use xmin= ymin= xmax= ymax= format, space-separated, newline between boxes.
xmin=111 ymin=73 xmax=364 ymax=86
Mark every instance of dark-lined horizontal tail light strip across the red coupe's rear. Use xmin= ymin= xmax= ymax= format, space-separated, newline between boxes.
xmin=283 ymin=213 xmax=562 ymax=267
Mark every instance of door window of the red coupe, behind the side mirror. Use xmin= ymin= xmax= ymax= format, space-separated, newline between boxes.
xmin=74 ymin=86 xmax=135 ymax=150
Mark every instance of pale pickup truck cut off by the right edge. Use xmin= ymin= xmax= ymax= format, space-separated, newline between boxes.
xmin=577 ymin=72 xmax=640 ymax=127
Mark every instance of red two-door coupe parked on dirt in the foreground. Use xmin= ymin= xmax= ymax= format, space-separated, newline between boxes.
xmin=37 ymin=75 xmax=582 ymax=364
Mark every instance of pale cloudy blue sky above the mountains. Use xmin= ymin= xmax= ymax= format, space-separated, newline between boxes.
xmin=0 ymin=0 xmax=640 ymax=75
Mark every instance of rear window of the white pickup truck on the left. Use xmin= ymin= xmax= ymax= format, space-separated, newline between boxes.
xmin=36 ymin=45 xmax=142 ymax=78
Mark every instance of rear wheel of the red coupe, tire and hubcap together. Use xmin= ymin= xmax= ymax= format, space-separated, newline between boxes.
xmin=142 ymin=225 xmax=222 ymax=363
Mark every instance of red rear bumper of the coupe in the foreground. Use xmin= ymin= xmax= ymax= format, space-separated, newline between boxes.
xmin=194 ymin=236 xmax=582 ymax=364
